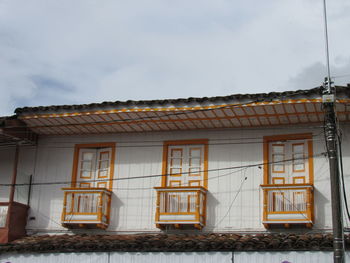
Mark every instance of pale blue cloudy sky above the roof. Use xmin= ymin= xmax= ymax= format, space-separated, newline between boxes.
xmin=0 ymin=0 xmax=350 ymax=116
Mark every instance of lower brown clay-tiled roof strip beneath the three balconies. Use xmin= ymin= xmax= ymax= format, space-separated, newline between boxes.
xmin=0 ymin=233 xmax=350 ymax=253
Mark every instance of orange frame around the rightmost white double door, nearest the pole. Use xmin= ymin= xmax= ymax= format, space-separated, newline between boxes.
xmin=263 ymin=133 xmax=314 ymax=185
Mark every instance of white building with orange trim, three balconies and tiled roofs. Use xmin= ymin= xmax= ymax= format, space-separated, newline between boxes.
xmin=0 ymin=86 xmax=350 ymax=262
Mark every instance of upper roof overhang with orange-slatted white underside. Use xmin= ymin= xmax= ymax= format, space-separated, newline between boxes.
xmin=16 ymin=85 xmax=350 ymax=135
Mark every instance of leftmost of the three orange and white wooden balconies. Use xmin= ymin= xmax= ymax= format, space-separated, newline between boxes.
xmin=62 ymin=188 xmax=112 ymax=229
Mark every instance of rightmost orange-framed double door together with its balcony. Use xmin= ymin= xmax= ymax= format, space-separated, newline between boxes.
xmin=261 ymin=134 xmax=314 ymax=228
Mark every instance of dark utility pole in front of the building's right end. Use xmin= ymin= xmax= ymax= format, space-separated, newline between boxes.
xmin=322 ymin=78 xmax=345 ymax=263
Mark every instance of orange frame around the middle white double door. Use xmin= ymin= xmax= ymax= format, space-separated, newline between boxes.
xmin=162 ymin=139 xmax=209 ymax=189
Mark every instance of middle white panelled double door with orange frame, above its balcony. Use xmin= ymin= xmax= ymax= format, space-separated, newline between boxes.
xmin=162 ymin=140 xmax=208 ymax=188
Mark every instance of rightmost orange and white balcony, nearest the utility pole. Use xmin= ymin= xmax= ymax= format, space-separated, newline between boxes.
xmin=261 ymin=184 xmax=314 ymax=228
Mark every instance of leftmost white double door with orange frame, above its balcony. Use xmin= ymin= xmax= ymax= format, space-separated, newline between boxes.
xmin=72 ymin=143 xmax=115 ymax=189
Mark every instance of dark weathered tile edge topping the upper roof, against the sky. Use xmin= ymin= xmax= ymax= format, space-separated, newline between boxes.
xmin=15 ymin=84 xmax=350 ymax=115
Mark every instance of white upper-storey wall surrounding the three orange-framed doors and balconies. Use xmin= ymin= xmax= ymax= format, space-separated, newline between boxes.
xmin=13 ymin=128 xmax=336 ymax=232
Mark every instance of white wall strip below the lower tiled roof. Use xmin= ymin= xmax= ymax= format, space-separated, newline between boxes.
xmin=4 ymin=251 xmax=350 ymax=263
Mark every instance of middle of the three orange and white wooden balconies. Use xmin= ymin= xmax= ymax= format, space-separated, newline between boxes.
xmin=155 ymin=187 xmax=207 ymax=229
